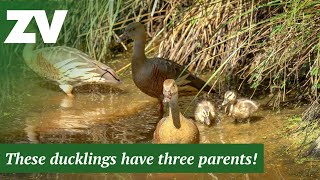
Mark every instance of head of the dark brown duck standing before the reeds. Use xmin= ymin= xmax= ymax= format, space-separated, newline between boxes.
xmin=120 ymin=22 xmax=145 ymax=41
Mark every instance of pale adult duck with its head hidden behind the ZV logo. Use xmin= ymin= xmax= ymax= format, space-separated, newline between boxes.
xmin=23 ymin=44 xmax=121 ymax=97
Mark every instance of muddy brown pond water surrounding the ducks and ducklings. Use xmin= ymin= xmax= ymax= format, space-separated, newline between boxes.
xmin=0 ymin=56 xmax=320 ymax=179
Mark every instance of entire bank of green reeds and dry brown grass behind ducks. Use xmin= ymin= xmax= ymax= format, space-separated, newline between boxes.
xmin=5 ymin=0 xmax=320 ymax=106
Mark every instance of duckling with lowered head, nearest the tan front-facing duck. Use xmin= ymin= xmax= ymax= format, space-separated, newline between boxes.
xmin=194 ymin=100 xmax=217 ymax=126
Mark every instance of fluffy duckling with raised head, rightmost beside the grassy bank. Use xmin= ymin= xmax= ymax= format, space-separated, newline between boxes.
xmin=222 ymin=91 xmax=259 ymax=121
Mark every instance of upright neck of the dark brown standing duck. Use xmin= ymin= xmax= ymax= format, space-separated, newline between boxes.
xmin=132 ymin=36 xmax=146 ymax=69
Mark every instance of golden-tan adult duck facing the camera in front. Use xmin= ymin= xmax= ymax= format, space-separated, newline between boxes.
xmin=153 ymin=79 xmax=200 ymax=144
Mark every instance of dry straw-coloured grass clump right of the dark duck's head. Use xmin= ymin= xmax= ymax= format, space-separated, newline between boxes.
xmin=159 ymin=0 xmax=320 ymax=105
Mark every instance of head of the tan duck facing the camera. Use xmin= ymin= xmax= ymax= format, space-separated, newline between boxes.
xmin=163 ymin=79 xmax=178 ymax=103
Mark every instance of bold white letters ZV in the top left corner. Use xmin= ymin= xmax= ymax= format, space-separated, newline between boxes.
xmin=4 ymin=10 xmax=68 ymax=43
